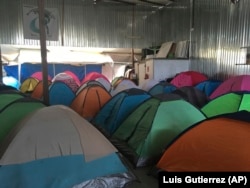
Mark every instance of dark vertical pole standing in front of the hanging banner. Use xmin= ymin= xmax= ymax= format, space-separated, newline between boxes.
xmin=38 ymin=0 xmax=49 ymax=105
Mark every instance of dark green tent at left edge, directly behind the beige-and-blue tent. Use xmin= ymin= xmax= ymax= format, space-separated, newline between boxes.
xmin=0 ymin=97 xmax=46 ymax=143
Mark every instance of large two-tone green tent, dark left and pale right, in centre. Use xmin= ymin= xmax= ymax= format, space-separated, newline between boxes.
xmin=111 ymin=97 xmax=206 ymax=167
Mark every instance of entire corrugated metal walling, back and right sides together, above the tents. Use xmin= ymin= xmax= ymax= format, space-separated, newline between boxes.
xmin=0 ymin=0 xmax=250 ymax=79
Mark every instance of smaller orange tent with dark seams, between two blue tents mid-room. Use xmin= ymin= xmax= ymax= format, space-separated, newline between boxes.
xmin=70 ymin=85 xmax=111 ymax=121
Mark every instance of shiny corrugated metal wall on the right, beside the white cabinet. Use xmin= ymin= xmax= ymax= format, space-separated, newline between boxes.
xmin=191 ymin=0 xmax=250 ymax=79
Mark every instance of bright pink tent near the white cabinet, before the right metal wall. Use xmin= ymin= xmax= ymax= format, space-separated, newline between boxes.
xmin=170 ymin=71 xmax=208 ymax=87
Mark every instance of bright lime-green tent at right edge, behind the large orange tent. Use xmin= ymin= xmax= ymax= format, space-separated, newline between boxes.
xmin=201 ymin=92 xmax=250 ymax=117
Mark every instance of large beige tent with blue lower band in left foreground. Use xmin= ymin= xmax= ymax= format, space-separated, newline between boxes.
xmin=0 ymin=105 xmax=134 ymax=188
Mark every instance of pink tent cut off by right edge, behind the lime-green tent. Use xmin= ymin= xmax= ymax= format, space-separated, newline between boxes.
xmin=209 ymin=75 xmax=250 ymax=99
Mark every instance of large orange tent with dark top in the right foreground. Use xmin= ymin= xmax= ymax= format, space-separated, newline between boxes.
xmin=157 ymin=111 xmax=250 ymax=172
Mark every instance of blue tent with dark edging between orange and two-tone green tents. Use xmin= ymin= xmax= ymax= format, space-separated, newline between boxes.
xmin=91 ymin=88 xmax=151 ymax=136
